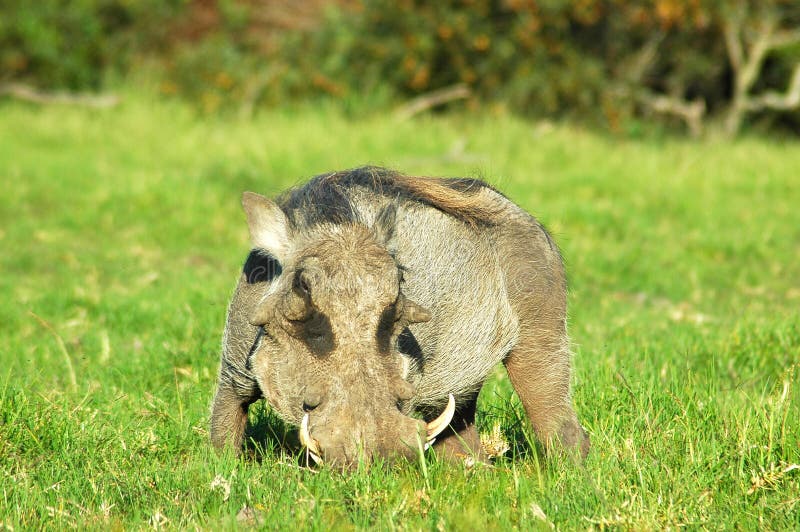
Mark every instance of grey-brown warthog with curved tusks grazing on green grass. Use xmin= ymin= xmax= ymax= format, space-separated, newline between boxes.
xmin=211 ymin=167 xmax=589 ymax=467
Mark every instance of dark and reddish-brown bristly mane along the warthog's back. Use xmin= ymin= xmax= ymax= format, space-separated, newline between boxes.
xmin=278 ymin=166 xmax=500 ymax=227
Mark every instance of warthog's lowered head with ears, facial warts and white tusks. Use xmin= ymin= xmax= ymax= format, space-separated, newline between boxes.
xmin=243 ymin=193 xmax=454 ymax=466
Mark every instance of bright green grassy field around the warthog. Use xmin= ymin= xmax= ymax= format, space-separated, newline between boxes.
xmin=0 ymin=97 xmax=800 ymax=530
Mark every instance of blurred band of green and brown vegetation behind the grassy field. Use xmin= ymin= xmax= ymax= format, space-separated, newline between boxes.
xmin=0 ymin=0 xmax=800 ymax=136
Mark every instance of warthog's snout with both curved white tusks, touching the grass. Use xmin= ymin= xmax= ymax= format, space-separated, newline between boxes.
xmin=300 ymin=394 xmax=455 ymax=468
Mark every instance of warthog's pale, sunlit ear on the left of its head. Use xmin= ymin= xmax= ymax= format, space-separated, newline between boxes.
xmin=242 ymin=192 xmax=296 ymax=262
